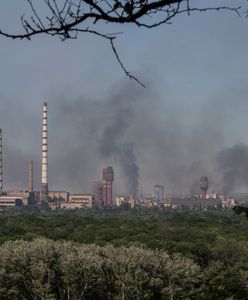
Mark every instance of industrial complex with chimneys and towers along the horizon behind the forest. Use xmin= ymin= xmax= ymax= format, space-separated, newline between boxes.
xmin=0 ymin=102 xmax=240 ymax=210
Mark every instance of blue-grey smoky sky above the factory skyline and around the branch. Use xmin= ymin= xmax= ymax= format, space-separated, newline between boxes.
xmin=0 ymin=0 xmax=248 ymax=194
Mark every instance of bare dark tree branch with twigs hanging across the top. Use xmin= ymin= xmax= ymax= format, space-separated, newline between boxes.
xmin=0 ymin=0 xmax=244 ymax=86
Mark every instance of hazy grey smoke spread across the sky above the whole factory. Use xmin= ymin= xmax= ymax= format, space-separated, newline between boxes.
xmin=2 ymin=79 xmax=248 ymax=195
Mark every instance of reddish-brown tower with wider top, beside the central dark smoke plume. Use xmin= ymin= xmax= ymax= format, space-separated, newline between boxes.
xmin=102 ymin=167 xmax=114 ymax=206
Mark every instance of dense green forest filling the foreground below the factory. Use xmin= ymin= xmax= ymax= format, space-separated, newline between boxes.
xmin=0 ymin=211 xmax=248 ymax=300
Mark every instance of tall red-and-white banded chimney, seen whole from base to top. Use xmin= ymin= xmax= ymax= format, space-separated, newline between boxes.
xmin=40 ymin=102 xmax=48 ymax=203
